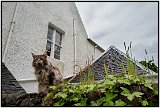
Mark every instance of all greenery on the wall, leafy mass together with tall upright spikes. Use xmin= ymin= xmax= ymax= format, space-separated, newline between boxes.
xmin=44 ymin=43 xmax=159 ymax=106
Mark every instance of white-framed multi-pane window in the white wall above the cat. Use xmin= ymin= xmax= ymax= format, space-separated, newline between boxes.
xmin=46 ymin=27 xmax=62 ymax=60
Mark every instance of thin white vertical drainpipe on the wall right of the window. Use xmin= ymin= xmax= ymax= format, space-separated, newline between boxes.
xmin=73 ymin=19 xmax=77 ymax=73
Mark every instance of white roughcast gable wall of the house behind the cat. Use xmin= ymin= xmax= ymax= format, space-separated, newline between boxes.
xmin=2 ymin=2 xmax=102 ymax=92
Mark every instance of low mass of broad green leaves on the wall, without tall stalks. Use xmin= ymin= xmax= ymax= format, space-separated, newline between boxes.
xmin=45 ymin=72 xmax=158 ymax=106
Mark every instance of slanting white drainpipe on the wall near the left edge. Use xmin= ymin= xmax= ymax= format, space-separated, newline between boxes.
xmin=2 ymin=2 xmax=18 ymax=62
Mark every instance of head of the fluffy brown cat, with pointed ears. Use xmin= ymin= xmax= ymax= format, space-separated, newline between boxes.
xmin=31 ymin=52 xmax=47 ymax=68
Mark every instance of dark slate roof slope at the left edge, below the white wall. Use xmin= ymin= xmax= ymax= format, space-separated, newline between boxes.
xmin=1 ymin=62 xmax=26 ymax=94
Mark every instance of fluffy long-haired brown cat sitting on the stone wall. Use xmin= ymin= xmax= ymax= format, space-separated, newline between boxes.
xmin=31 ymin=52 xmax=63 ymax=94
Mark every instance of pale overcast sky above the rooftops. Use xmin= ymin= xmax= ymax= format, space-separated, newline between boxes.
xmin=76 ymin=2 xmax=158 ymax=64
